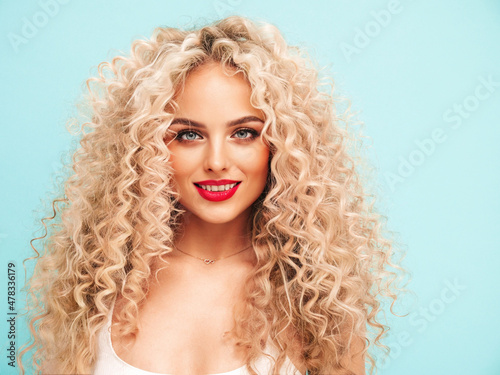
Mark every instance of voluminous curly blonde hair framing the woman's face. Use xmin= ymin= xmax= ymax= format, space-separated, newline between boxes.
xmin=19 ymin=16 xmax=404 ymax=374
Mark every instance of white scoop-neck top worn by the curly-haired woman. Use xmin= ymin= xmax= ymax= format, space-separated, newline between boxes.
xmin=92 ymin=310 xmax=301 ymax=375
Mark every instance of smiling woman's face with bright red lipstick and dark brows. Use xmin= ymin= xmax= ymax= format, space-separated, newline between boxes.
xmin=166 ymin=63 xmax=269 ymax=223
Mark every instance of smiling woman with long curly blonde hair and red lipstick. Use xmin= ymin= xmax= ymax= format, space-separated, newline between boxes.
xmin=22 ymin=16 xmax=408 ymax=375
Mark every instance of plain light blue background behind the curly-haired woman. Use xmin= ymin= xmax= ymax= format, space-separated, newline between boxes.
xmin=0 ymin=0 xmax=500 ymax=375
